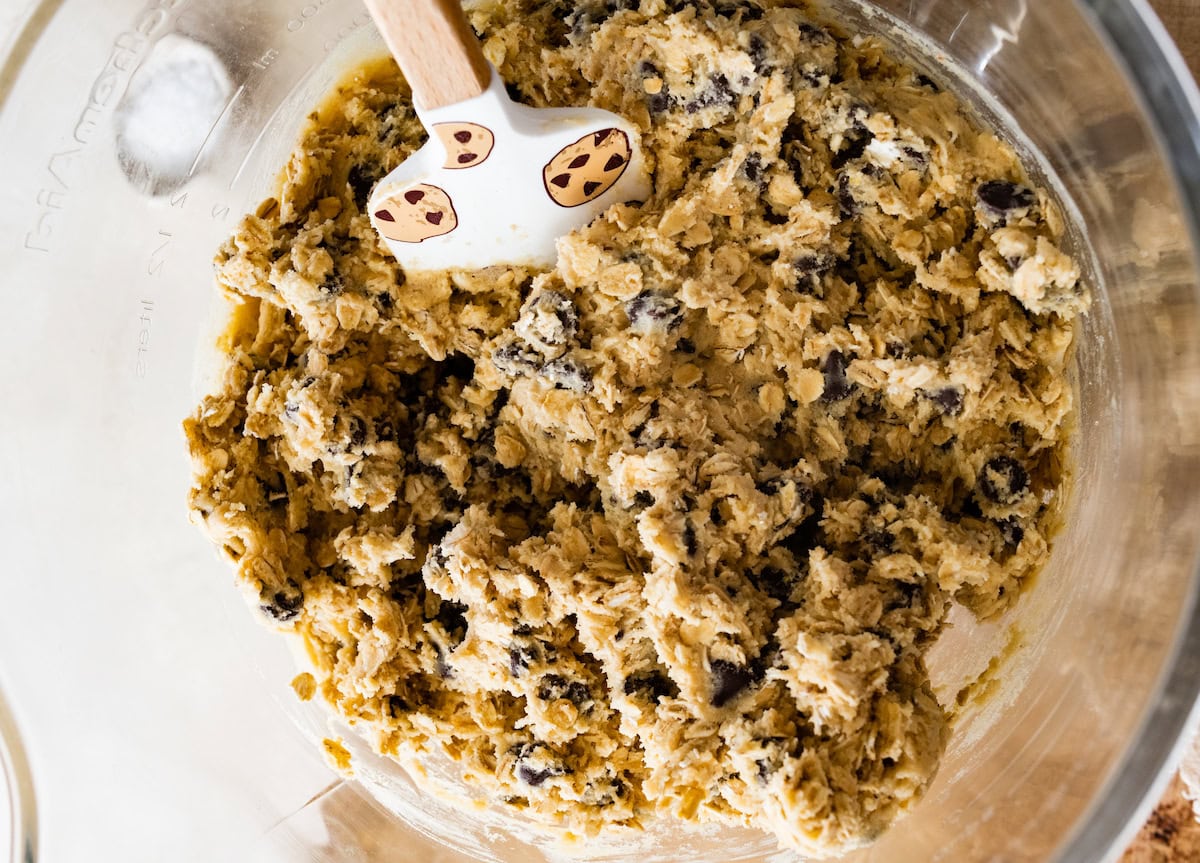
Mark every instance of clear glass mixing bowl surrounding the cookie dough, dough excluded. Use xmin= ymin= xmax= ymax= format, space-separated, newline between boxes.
xmin=0 ymin=0 xmax=1200 ymax=863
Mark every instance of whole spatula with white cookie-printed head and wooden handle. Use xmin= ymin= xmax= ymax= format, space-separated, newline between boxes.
xmin=367 ymin=0 xmax=650 ymax=270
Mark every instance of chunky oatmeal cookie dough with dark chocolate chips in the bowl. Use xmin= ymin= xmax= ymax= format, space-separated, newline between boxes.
xmin=186 ymin=0 xmax=1087 ymax=856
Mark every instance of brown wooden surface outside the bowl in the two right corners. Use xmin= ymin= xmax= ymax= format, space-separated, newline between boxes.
xmin=1121 ymin=0 xmax=1200 ymax=863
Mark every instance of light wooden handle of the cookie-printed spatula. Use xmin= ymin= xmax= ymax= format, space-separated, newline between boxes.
xmin=365 ymin=0 xmax=492 ymax=109
